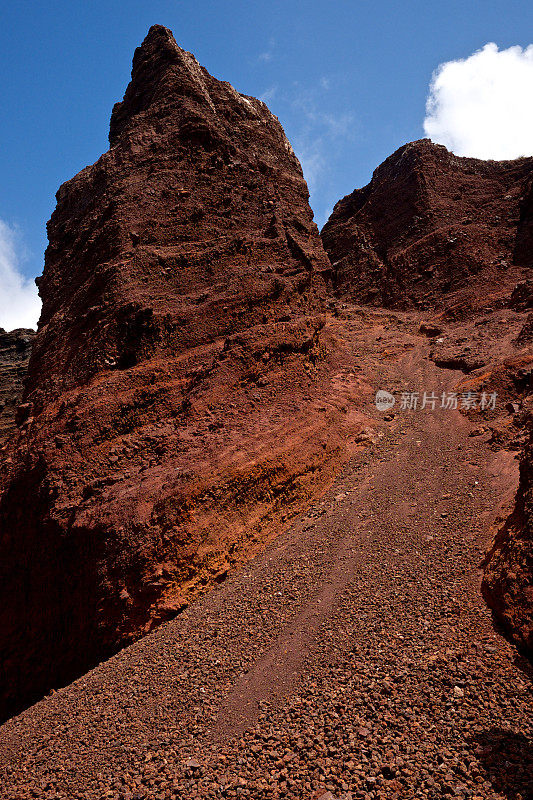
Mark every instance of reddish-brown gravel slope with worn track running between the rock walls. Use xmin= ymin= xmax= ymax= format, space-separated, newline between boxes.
xmin=0 ymin=312 xmax=533 ymax=800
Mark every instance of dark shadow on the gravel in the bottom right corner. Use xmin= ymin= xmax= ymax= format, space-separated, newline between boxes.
xmin=474 ymin=728 xmax=533 ymax=800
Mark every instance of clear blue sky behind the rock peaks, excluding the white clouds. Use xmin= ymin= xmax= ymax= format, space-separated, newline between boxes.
xmin=0 ymin=0 xmax=533 ymax=325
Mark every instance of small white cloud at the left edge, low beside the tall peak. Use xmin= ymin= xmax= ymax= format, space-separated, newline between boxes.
xmin=0 ymin=220 xmax=41 ymax=331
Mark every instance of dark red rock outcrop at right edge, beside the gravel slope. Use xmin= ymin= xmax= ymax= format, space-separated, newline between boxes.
xmin=482 ymin=409 xmax=533 ymax=659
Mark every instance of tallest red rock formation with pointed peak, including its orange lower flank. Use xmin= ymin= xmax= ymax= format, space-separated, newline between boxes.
xmin=0 ymin=26 xmax=358 ymax=715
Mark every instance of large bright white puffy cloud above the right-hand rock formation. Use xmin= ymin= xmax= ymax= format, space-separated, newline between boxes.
xmin=424 ymin=42 xmax=533 ymax=160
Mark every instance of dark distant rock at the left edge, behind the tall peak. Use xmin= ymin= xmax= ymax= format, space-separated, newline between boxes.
xmin=0 ymin=328 xmax=35 ymax=447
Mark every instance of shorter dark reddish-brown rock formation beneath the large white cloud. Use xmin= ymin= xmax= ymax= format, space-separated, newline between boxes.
xmin=322 ymin=139 xmax=533 ymax=308
